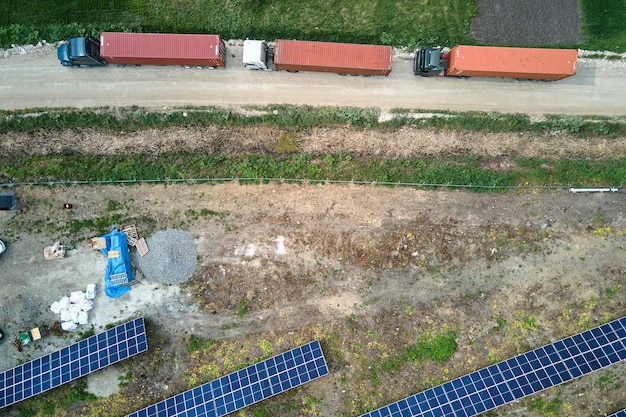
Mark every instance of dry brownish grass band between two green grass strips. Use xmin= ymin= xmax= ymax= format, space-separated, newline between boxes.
xmin=0 ymin=125 xmax=626 ymax=160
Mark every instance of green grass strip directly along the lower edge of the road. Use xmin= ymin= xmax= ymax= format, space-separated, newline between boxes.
xmin=0 ymin=105 xmax=626 ymax=136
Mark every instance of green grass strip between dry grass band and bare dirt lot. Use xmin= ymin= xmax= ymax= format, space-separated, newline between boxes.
xmin=0 ymin=153 xmax=626 ymax=190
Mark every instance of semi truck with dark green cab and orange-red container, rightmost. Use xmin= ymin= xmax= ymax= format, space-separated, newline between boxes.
xmin=413 ymin=45 xmax=578 ymax=81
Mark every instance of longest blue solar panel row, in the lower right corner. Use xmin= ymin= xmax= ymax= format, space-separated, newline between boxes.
xmin=362 ymin=317 xmax=626 ymax=417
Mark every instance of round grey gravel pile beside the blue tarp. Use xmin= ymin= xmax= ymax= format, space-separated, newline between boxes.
xmin=135 ymin=229 xmax=198 ymax=284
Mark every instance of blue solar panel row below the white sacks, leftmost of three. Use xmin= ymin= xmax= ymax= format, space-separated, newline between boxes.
xmin=0 ymin=317 xmax=148 ymax=408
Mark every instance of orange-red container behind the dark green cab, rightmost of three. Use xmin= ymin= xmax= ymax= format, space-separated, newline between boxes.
xmin=446 ymin=45 xmax=578 ymax=80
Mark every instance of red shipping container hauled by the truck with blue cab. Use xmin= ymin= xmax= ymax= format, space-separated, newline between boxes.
xmin=100 ymin=32 xmax=226 ymax=67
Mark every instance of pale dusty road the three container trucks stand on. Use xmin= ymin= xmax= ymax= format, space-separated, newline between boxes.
xmin=0 ymin=48 xmax=626 ymax=115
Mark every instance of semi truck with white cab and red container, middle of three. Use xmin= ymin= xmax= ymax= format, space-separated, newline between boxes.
xmin=243 ymin=39 xmax=393 ymax=76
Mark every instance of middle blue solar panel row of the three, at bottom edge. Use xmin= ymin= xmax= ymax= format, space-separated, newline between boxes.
xmin=127 ymin=340 xmax=328 ymax=417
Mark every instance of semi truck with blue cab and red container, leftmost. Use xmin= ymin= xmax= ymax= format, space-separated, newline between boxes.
xmin=57 ymin=32 xmax=226 ymax=67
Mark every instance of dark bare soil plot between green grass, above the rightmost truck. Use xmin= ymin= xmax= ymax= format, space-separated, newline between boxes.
xmin=470 ymin=0 xmax=582 ymax=46
